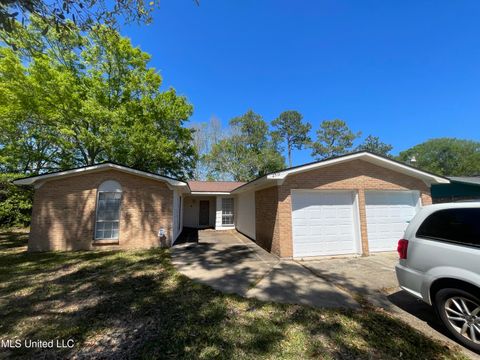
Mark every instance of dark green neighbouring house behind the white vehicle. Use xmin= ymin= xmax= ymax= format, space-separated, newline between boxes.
xmin=432 ymin=176 xmax=480 ymax=204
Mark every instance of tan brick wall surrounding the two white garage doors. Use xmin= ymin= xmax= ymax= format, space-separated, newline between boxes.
xmin=256 ymin=160 xmax=432 ymax=257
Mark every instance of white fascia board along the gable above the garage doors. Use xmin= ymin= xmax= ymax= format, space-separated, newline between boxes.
xmin=267 ymin=153 xmax=450 ymax=184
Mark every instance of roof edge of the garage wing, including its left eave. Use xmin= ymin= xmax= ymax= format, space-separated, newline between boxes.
xmin=233 ymin=151 xmax=450 ymax=193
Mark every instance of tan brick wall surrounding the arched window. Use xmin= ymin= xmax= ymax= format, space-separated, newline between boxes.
xmin=28 ymin=170 xmax=173 ymax=251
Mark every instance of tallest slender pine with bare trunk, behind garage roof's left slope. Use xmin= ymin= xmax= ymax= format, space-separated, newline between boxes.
xmin=272 ymin=110 xmax=312 ymax=167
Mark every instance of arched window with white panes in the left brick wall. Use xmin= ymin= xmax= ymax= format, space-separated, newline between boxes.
xmin=95 ymin=180 xmax=122 ymax=240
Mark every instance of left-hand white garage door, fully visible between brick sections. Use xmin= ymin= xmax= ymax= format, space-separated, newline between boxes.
xmin=292 ymin=191 xmax=356 ymax=257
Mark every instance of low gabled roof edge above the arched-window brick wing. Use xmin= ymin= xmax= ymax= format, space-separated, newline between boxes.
xmin=13 ymin=162 xmax=188 ymax=189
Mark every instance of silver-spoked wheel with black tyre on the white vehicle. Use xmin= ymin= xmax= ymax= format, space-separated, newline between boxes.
xmin=434 ymin=289 xmax=480 ymax=352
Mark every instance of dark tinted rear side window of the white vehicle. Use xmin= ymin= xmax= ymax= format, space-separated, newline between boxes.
xmin=417 ymin=208 xmax=480 ymax=246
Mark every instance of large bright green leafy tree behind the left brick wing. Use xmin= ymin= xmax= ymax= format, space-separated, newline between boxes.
xmin=0 ymin=19 xmax=196 ymax=177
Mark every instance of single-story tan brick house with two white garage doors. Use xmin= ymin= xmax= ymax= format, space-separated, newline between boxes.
xmin=14 ymin=151 xmax=449 ymax=258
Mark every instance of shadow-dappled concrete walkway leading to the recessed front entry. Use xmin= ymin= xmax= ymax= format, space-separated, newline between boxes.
xmin=172 ymin=230 xmax=359 ymax=308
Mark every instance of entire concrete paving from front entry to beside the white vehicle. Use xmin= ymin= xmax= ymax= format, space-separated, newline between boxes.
xmin=172 ymin=230 xmax=478 ymax=358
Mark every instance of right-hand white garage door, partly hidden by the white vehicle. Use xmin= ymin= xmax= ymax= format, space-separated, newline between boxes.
xmin=365 ymin=191 xmax=419 ymax=252
